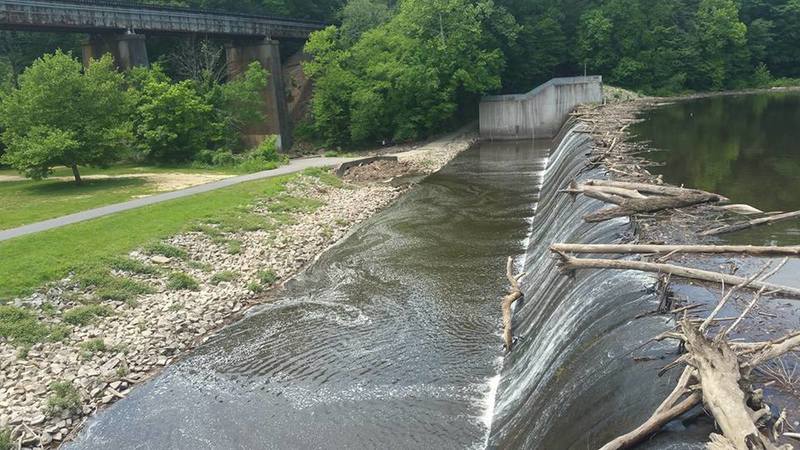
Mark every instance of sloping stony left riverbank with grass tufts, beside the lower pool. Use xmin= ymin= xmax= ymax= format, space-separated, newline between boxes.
xmin=0 ymin=129 xmax=475 ymax=448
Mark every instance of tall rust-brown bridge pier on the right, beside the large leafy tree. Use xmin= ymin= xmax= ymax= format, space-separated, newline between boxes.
xmin=225 ymin=38 xmax=292 ymax=151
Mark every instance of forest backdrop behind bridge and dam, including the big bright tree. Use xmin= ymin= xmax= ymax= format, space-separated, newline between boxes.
xmin=0 ymin=0 xmax=800 ymax=156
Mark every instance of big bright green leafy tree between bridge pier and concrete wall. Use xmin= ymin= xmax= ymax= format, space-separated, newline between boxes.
xmin=305 ymin=0 xmax=504 ymax=145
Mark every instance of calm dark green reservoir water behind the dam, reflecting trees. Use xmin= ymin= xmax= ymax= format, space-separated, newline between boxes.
xmin=633 ymin=93 xmax=800 ymax=244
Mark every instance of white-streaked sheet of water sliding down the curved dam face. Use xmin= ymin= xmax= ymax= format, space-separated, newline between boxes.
xmin=488 ymin=123 xmax=709 ymax=450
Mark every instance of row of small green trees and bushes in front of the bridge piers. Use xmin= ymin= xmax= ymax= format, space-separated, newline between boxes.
xmin=0 ymin=51 xmax=279 ymax=183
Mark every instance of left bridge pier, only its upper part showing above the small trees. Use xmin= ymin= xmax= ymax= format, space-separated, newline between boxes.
xmin=83 ymin=33 xmax=150 ymax=70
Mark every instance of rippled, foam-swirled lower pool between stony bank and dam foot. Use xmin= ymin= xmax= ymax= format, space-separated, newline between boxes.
xmin=68 ymin=142 xmax=547 ymax=449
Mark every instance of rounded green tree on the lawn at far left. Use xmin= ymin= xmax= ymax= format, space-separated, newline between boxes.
xmin=0 ymin=50 xmax=131 ymax=184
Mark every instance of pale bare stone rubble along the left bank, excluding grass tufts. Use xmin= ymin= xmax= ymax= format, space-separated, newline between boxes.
xmin=0 ymin=132 xmax=475 ymax=449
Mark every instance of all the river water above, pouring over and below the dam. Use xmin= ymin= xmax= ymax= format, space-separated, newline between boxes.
xmin=71 ymin=95 xmax=800 ymax=450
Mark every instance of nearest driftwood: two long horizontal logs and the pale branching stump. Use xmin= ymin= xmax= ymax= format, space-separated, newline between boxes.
xmin=551 ymin=244 xmax=800 ymax=450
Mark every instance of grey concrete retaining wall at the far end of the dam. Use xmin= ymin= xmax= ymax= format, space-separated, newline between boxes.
xmin=480 ymin=76 xmax=603 ymax=140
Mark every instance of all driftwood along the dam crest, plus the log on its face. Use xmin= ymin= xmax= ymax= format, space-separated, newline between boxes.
xmin=494 ymin=103 xmax=800 ymax=450
